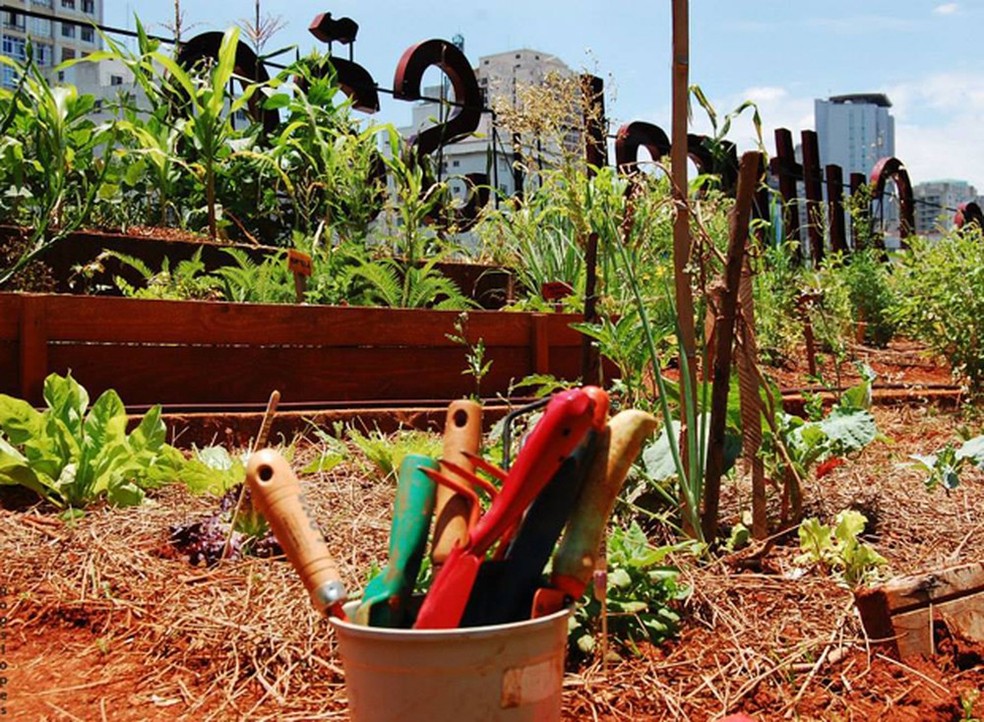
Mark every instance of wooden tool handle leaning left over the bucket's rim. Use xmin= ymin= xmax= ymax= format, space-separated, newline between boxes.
xmin=246 ymin=449 xmax=346 ymax=616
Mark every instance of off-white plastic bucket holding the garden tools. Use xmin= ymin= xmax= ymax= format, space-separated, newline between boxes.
xmin=331 ymin=603 xmax=570 ymax=722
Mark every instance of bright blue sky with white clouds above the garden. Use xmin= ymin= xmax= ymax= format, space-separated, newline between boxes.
xmin=104 ymin=0 xmax=984 ymax=193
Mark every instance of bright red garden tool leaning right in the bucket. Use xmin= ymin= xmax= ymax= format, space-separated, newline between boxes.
xmin=414 ymin=389 xmax=595 ymax=629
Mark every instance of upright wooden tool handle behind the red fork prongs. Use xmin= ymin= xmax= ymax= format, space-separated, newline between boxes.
xmin=431 ymin=399 xmax=482 ymax=564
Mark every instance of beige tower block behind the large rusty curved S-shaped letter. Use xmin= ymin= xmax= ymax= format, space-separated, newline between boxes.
xmin=402 ymin=46 xmax=572 ymax=198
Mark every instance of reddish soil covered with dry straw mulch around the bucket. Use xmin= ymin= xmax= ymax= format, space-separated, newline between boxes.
xmin=0 ymin=346 xmax=984 ymax=721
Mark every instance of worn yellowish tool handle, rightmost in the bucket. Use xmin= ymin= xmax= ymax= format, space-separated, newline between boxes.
xmin=552 ymin=409 xmax=657 ymax=598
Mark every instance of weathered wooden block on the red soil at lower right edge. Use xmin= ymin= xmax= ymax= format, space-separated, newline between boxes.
xmin=855 ymin=562 xmax=984 ymax=659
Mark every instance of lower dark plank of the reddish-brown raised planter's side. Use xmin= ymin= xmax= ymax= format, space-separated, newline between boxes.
xmin=50 ymin=344 xmax=530 ymax=405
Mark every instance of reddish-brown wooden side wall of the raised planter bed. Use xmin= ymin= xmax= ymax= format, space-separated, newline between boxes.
xmin=0 ymin=293 xmax=581 ymax=407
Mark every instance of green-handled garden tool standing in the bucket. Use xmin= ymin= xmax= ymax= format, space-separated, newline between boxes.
xmin=355 ymin=454 xmax=437 ymax=627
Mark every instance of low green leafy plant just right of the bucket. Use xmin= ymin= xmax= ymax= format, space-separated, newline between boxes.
xmin=568 ymin=522 xmax=693 ymax=655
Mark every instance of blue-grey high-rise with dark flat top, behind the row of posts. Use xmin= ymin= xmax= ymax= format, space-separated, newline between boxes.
xmin=813 ymin=93 xmax=895 ymax=178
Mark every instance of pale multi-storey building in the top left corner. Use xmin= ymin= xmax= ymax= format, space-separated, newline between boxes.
xmin=0 ymin=0 xmax=103 ymax=87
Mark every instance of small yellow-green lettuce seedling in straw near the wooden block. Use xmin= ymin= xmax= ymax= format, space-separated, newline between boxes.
xmin=796 ymin=510 xmax=888 ymax=588
